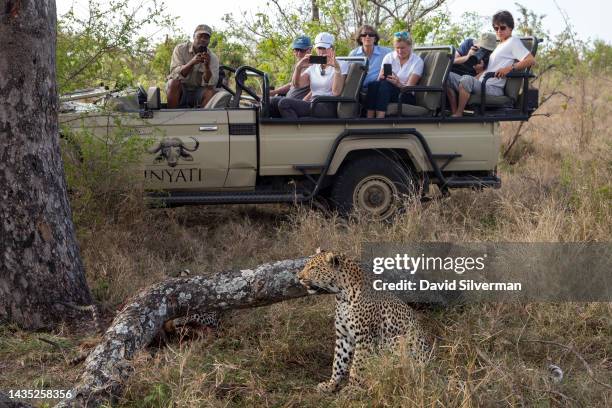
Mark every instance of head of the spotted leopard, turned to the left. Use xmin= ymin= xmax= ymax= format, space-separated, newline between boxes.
xmin=298 ymin=249 xmax=352 ymax=295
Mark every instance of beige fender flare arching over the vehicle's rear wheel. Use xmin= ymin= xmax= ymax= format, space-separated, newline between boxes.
xmin=327 ymin=136 xmax=432 ymax=175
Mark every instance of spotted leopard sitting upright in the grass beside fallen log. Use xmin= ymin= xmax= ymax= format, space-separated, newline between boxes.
xmin=297 ymin=249 xmax=432 ymax=393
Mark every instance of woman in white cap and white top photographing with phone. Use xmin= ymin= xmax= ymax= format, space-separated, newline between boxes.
xmin=278 ymin=32 xmax=348 ymax=119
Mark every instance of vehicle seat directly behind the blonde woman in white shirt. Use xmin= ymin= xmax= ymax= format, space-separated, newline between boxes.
xmin=387 ymin=47 xmax=453 ymax=116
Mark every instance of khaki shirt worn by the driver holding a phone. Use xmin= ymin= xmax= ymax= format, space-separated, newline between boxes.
xmin=168 ymin=41 xmax=219 ymax=88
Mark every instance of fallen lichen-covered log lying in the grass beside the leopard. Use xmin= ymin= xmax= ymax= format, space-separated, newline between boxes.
xmin=56 ymin=258 xmax=308 ymax=408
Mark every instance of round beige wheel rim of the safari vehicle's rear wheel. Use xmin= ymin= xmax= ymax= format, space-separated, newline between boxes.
xmin=353 ymin=175 xmax=398 ymax=219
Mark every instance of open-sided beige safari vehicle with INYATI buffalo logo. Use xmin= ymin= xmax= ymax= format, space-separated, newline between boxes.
xmin=62 ymin=37 xmax=538 ymax=219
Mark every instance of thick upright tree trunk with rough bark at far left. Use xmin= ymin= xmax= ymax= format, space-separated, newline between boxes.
xmin=0 ymin=0 xmax=91 ymax=329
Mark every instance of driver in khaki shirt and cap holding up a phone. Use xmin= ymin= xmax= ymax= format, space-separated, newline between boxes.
xmin=166 ymin=24 xmax=219 ymax=109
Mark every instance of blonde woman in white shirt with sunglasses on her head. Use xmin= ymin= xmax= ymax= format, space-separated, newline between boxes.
xmin=366 ymin=31 xmax=424 ymax=118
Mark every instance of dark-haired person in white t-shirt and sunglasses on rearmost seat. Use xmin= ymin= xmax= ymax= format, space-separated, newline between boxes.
xmin=449 ymin=10 xmax=535 ymax=117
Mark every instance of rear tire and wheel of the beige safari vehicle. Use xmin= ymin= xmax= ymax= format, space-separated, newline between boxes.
xmin=330 ymin=154 xmax=417 ymax=220
